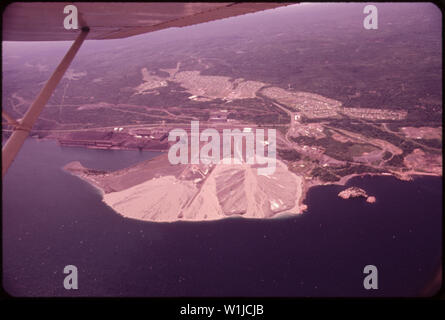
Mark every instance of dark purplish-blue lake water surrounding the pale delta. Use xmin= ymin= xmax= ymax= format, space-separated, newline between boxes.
xmin=3 ymin=140 xmax=442 ymax=297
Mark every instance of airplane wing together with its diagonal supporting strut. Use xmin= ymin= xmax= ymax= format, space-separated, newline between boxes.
xmin=2 ymin=2 xmax=291 ymax=177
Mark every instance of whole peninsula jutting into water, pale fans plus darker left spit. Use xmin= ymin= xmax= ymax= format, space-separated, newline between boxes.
xmin=64 ymin=154 xmax=305 ymax=222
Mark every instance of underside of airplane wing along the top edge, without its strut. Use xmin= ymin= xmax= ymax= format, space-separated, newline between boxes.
xmin=3 ymin=2 xmax=292 ymax=41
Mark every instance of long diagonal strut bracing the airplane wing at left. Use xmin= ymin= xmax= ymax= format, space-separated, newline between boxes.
xmin=2 ymin=27 xmax=89 ymax=177
